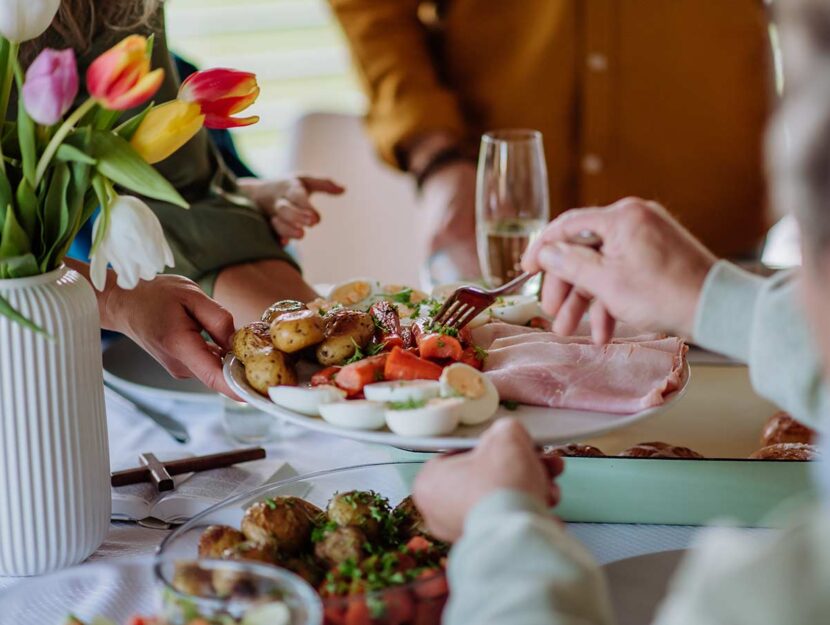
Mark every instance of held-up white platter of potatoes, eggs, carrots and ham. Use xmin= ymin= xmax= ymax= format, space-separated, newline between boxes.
xmin=225 ymin=279 xmax=689 ymax=451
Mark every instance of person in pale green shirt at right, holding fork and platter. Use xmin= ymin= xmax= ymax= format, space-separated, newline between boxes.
xmin=414 ymin=0 xmax=830 ymax=625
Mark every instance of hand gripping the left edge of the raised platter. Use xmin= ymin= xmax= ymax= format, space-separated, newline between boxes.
xmin=101 ymin=275 xmax=239 ymax=399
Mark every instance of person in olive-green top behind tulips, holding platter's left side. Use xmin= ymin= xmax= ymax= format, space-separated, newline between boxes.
xmin=21 ymin=0 xmax=343 ymax=395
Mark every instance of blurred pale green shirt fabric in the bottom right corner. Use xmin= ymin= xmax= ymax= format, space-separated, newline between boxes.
xmin=653 ymin=511 xmax=830 ymax=625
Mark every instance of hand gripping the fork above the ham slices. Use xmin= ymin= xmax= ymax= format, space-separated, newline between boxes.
xmin=522 ymin=198 xmax=717 ymax=343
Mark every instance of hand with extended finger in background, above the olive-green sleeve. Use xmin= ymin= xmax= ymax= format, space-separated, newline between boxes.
xmin=239 ymin=176 xmax=345 ymax=245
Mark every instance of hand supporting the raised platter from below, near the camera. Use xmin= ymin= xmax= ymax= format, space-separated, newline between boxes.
xmin=412 ymin=419 xmax=564 ymax=541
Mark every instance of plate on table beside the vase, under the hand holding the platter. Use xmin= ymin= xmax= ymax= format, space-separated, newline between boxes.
xmin=102 ymin=338 xmax=217 ymax=403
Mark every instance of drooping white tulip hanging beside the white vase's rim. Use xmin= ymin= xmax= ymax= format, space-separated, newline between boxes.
xmin=89 ymin=195 xmax=174 ymax=291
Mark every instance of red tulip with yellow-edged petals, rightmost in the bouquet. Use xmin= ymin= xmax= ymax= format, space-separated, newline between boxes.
xmin=179 ymin=68 xmax=259 ymax=128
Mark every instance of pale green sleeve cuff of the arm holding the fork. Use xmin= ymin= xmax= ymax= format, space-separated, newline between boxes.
xmin=694 ymin=261 xmax=830 ymax=427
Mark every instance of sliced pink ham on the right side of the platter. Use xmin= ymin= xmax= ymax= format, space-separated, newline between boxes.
xmin=480 ymin=324 xmax=686 ymax=414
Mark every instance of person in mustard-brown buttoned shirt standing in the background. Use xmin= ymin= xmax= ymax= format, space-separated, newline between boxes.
xmin=329 ymin=0 xmax=772 ymax=282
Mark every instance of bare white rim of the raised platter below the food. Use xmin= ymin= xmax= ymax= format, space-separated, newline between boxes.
xmin=224 ymin=355 xmax=690 ymax=451
